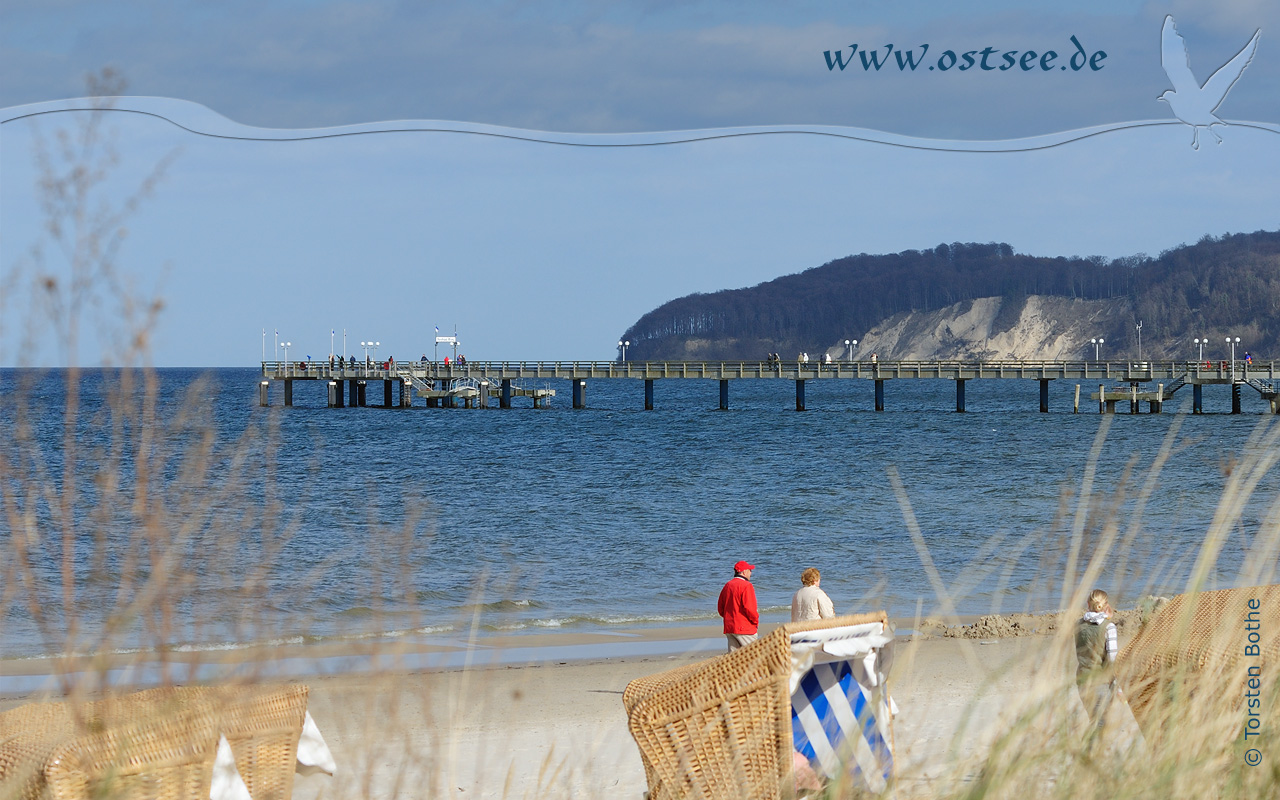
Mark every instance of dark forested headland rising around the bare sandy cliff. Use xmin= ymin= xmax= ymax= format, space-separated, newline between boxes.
xmin=622 ymin=232 xmax=1280 ymax=360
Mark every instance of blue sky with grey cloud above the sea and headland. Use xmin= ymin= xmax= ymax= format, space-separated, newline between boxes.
xmin=0 ymin=0 xmax=1280 ymax=366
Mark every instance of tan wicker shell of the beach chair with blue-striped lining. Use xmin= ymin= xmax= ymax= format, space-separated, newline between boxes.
xmin=622 ymin=612 xmax=892 ymax=800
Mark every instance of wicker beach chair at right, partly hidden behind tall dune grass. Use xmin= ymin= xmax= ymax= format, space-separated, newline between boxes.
xmin=1119 ymin=585 xmax=1280 ymax=736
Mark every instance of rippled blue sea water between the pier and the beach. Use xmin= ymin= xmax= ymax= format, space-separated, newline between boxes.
xmin=0 ymin=369 xmax=1280 ymax=657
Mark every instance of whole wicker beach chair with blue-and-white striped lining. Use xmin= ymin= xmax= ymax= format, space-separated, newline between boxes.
xmin=622 ymin=612 xmax=893 ymax=800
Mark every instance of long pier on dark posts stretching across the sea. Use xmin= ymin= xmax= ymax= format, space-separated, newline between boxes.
xmin=259 ymin=361 xmax=1280 ymax=413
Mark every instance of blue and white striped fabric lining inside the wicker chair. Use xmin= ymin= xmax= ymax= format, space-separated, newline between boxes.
xmin=791 ymin=660 xmax=893 ymax=791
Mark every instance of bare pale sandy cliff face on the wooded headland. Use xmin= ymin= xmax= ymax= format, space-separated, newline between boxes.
xmin=827 ymin=296 xmax=1130 ymax=361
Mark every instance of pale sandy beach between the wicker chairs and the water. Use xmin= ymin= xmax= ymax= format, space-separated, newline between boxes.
xmin=0 ymin=621 xmax=1141 ymax=799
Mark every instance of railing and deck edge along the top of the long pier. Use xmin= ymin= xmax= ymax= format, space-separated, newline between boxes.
xmin=262 ymin=360 xmax=1276 ymax=383
